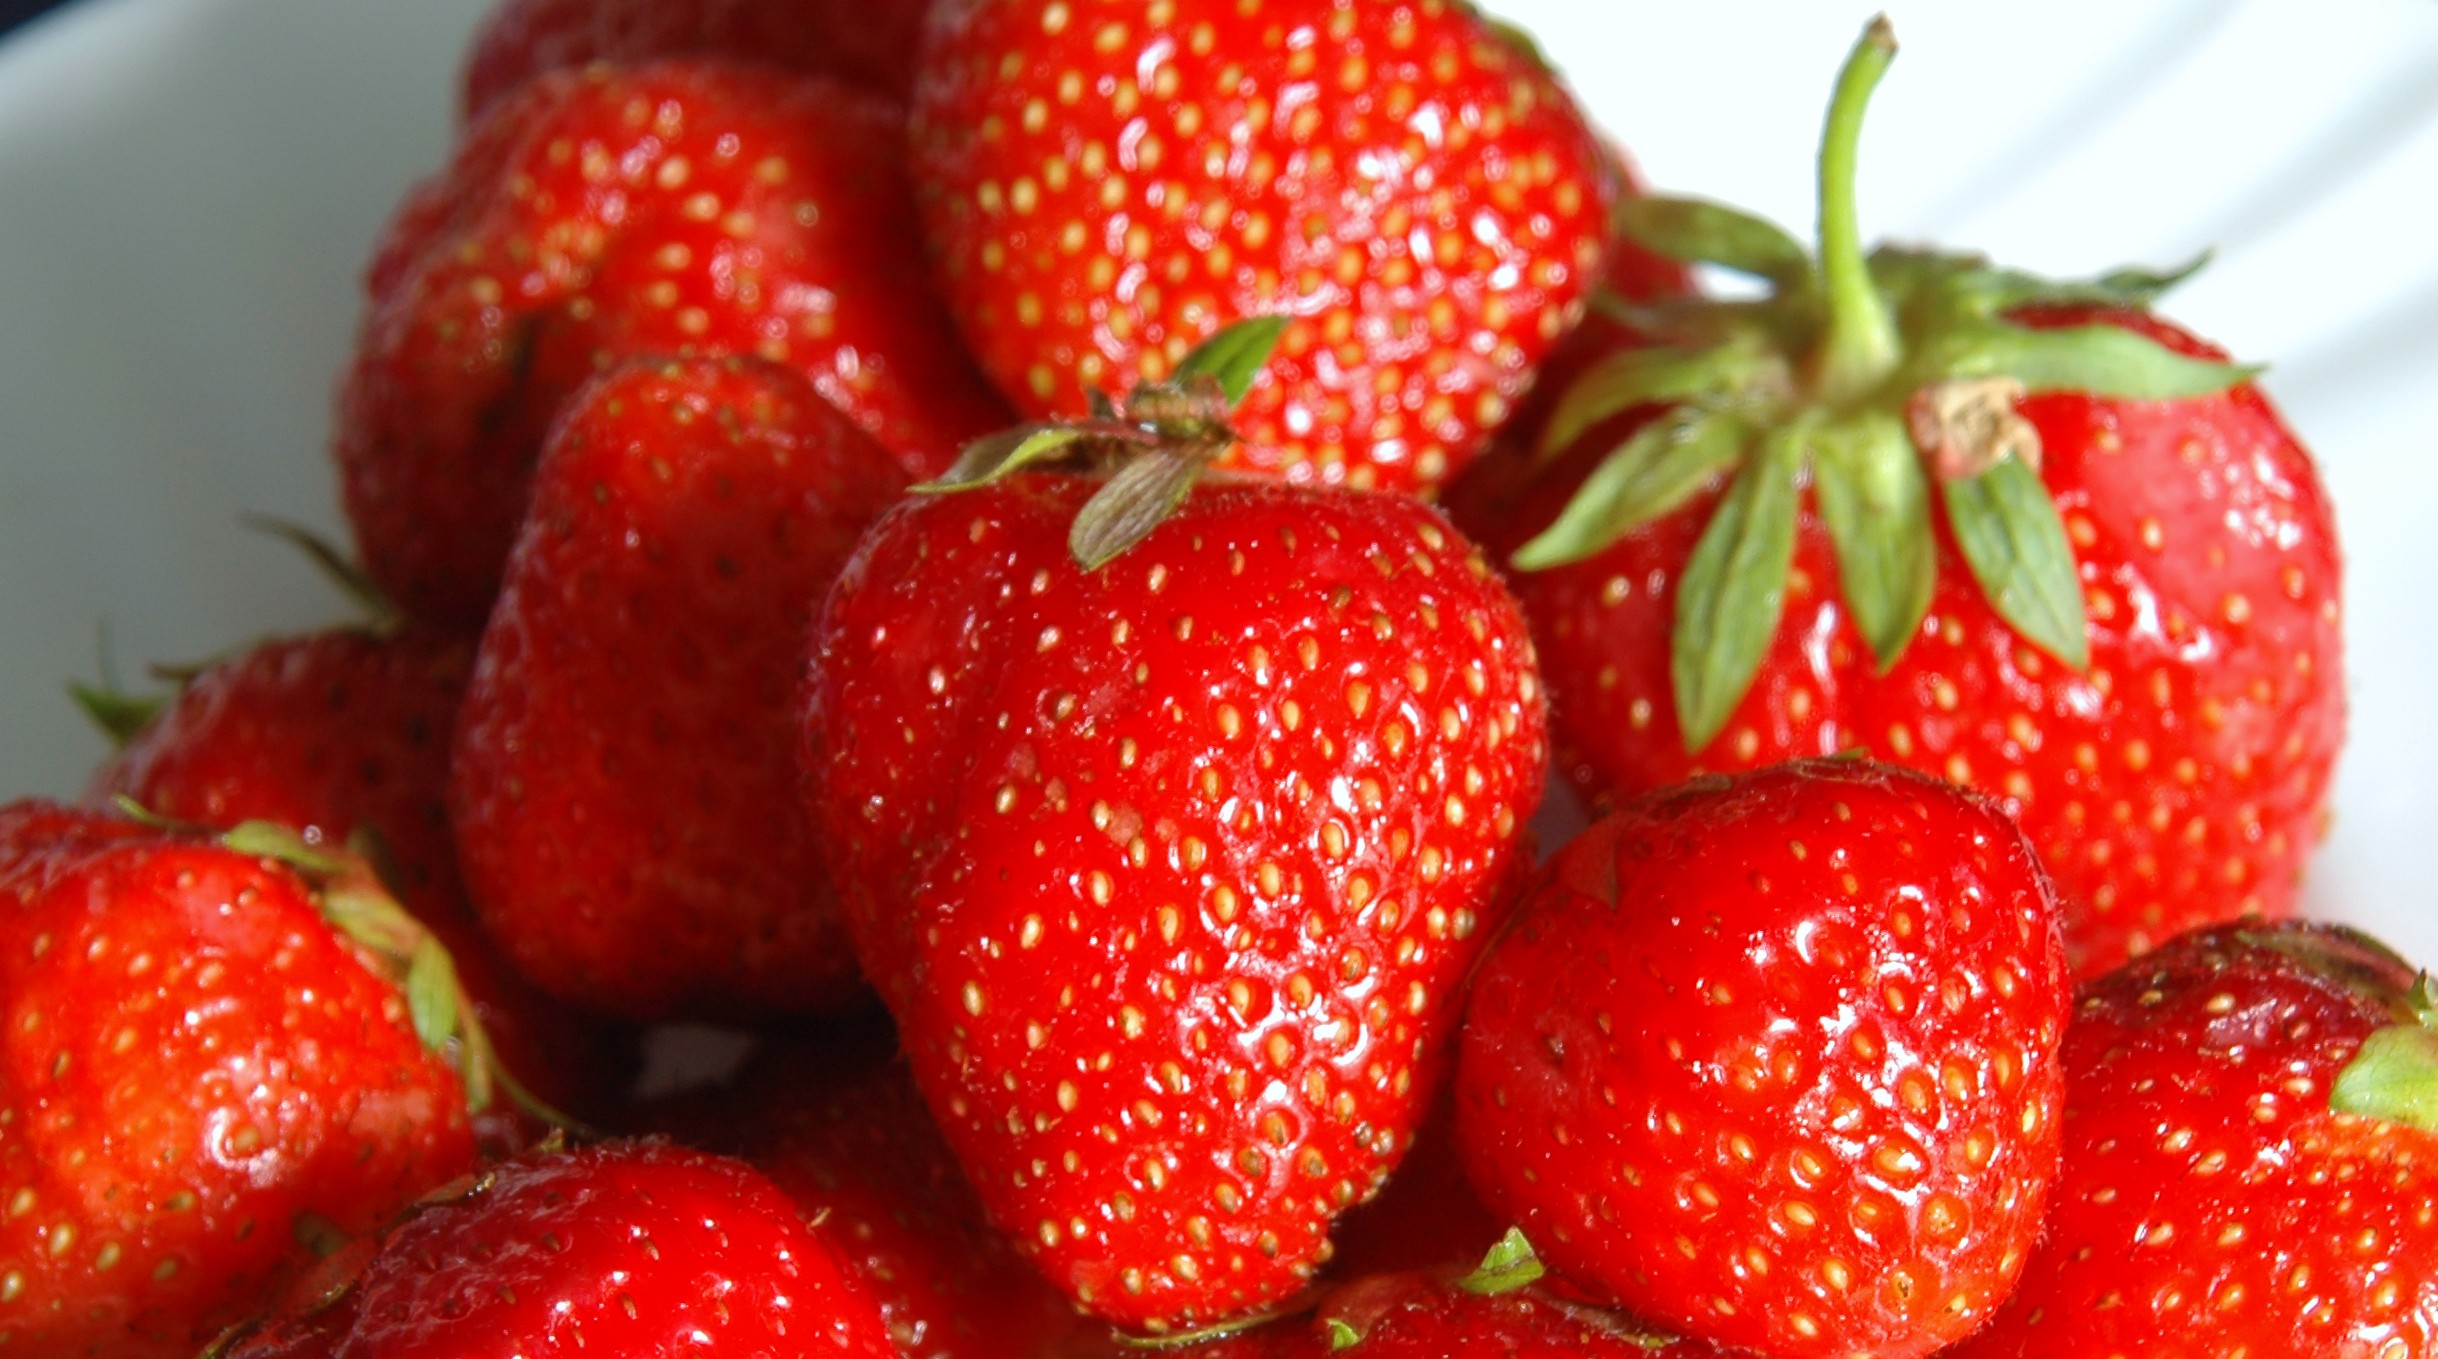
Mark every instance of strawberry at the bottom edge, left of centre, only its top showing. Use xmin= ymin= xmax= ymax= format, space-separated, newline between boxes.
xmin=227 ymin=1142 xmax=895 ymax=1359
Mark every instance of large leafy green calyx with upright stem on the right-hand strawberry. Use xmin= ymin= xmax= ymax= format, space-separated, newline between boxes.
xmin=1514 ymin=17 xmax=2258 ymax=751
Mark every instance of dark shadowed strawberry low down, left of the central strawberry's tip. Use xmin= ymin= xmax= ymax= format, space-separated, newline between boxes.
xmin=682 ymin=1030 xmax=1107 ymax=1359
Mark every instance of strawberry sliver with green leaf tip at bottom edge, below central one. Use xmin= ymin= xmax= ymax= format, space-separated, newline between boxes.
xmin=1199 ymin=1232 xmax=1729 ymax=1359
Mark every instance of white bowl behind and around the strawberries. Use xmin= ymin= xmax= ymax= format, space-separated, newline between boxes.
xmin=0 ymin=0 xmax=2438 ymax=959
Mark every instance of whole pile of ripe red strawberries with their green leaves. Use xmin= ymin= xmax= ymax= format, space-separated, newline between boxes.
xmin=0 ymin=0 xmax=2438 ymax=1359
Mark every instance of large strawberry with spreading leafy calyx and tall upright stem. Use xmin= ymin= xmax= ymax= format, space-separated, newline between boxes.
xmin=1455 ymin=27 xmax=2343 ymax=971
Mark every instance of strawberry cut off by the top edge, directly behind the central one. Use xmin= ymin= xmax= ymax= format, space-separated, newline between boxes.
xmin=912 ymin=0 xmax=1616 ymax=490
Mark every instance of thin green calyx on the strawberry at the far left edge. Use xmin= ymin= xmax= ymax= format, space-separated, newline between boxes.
xmin=117 ymin=795 xmax=588 ymax=1135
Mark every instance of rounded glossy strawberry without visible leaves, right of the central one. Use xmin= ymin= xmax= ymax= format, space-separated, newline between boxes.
xmin=1455 ymin=761 xmax=2067 ymax=1359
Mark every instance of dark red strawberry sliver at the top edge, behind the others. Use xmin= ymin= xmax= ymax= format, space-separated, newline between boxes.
xmin=466 ymin=0 xmax=926 ymax=117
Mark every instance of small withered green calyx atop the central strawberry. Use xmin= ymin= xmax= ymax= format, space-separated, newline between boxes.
xmin=914 ymin=317 xmax=1287 ymax=571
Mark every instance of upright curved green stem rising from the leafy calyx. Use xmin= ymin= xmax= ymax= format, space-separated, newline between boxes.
xmin=1814 ymin=15 xmax=1902 ymax=405
